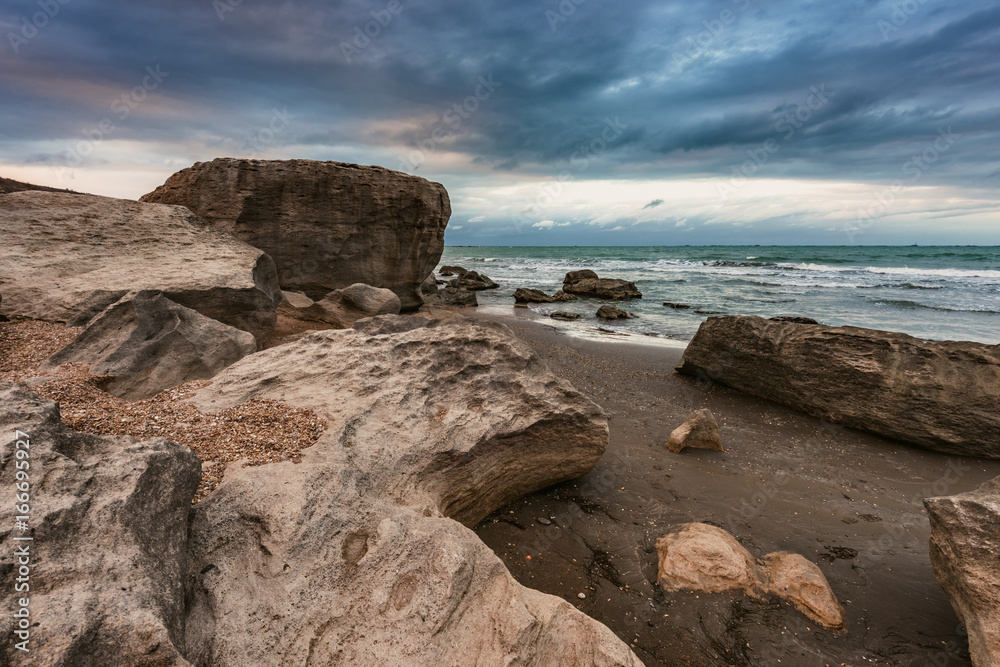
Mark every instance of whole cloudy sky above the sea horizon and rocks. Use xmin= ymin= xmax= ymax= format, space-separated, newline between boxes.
xmin=0 ymin=0 xmax=1000 ymax=245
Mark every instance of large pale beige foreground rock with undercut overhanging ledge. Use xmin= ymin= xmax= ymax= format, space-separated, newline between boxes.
xmin=180 ymin=318 xmax=641 ymax=667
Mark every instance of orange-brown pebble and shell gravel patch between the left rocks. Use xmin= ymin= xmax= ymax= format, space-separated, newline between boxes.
xmin=0 ymin=320 xmax=326 ymax=502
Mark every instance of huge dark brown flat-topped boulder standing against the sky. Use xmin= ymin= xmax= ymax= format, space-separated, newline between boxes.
xmin=142 ymin=158 xmax=451 ymax=310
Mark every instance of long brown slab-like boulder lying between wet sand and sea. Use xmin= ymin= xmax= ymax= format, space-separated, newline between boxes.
xmin=678 ymin=317 xmax=1000 ymax=458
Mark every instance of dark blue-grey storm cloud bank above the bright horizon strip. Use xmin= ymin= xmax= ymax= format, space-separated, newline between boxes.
xmin=0 ymin=0 xmax=1000 ymax=188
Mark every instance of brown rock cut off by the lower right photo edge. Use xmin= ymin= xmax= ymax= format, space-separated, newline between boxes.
xmin=924 ymin=477 xmax=1000 ymax=667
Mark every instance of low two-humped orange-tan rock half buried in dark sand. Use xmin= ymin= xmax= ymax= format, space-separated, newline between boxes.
xmin=656 ymin=523 xmax=846 ymax=632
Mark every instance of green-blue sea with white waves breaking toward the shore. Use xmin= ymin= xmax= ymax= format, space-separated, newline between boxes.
xmin=439 ymin=246 xmax=1000 ymax=344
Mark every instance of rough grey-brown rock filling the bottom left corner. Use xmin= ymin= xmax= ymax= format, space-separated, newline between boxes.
xmin=0 ymin=382 xmax=201 ymax=667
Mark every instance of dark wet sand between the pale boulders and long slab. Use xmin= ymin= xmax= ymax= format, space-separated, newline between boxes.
xmin=473 ymin=309 xmax=1000 ymax=667
